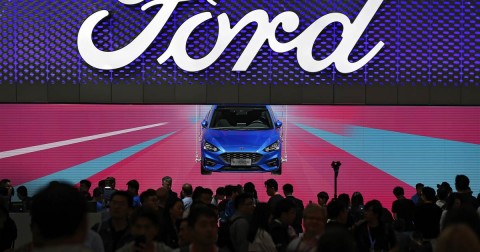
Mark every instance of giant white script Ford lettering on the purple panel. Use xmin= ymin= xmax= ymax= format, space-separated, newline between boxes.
xmin=78 ymin=0 xmax=384 ymax=73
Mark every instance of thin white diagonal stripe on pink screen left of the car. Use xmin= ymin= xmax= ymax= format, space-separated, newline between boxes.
xmin=0 ymin=122 xmax=167 ymax=159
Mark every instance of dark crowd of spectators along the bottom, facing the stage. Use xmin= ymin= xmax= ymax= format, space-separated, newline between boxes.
xmin=0 ymin=175 xmax=480 ymax=252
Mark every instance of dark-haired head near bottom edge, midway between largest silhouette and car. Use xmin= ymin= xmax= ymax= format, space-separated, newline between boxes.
xmin=130 ymin=207 xmax=161 ymax=244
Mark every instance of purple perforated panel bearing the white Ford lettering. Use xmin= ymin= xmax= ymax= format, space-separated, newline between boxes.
xmin=0 ymin=0 xmax=480 ymax=86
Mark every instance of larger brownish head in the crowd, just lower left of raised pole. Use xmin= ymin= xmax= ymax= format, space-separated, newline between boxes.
xmin=303 ymin=203 xmax=327 ymax=236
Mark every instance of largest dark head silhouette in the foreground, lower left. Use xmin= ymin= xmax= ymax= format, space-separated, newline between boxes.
xmin=30 ymin=182 xmax=87 ymax=246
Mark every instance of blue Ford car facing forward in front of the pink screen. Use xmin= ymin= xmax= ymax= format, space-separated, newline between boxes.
xmin=200 ymin=105 xmax=282 ymax=174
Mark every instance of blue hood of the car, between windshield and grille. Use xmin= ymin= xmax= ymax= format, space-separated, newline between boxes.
xmin=204 ymin=129 xmax=280 ymax=150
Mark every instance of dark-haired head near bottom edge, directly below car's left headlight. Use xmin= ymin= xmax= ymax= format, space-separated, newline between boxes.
xmin=188 ymin=204 xmax=218 ymax=247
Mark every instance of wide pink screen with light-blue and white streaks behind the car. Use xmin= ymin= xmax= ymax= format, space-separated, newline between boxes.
xmin=0 ymin=104 xmax=480 ymax=208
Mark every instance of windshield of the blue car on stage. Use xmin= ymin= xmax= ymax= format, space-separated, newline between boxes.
xmin=210 ymin=107 xmax=273 ymax=130
